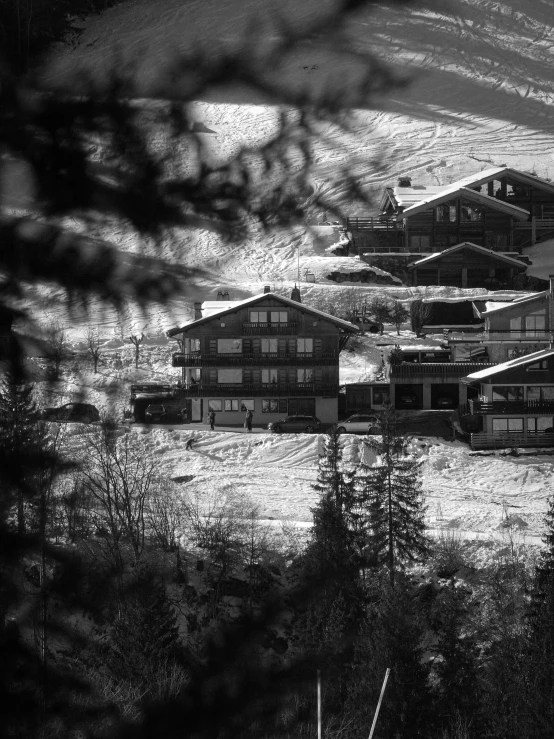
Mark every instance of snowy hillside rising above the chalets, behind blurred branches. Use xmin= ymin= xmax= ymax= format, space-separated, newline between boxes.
xmin=40 ymin=0 xmax=554 ymax=326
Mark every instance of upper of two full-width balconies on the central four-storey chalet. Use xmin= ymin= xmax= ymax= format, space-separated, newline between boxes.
xmin=172 ymin=352 xmax=339 ymax=367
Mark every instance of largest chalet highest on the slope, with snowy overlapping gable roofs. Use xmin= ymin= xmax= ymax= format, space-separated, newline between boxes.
xmin=346 ymin=167 xmax=554 ymax=255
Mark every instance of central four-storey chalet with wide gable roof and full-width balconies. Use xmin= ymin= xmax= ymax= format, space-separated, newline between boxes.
xmin=167 ymin=292 xmax=359 ymax=426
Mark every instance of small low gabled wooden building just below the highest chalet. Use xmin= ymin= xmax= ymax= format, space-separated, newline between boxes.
xmin=407 ymin=241 xmax=526 ymax=290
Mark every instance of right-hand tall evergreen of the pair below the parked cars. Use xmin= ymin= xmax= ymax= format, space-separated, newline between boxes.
xmin=356 ymin=408 xmax=428 ymax=585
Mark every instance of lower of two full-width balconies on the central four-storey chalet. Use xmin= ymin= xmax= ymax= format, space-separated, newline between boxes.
xmin=177 ymin=382 xmax=339 ymax=399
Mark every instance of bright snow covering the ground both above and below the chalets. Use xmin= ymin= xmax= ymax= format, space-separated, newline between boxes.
xmin=31 ymin=0 xmax=554 ymax=538
